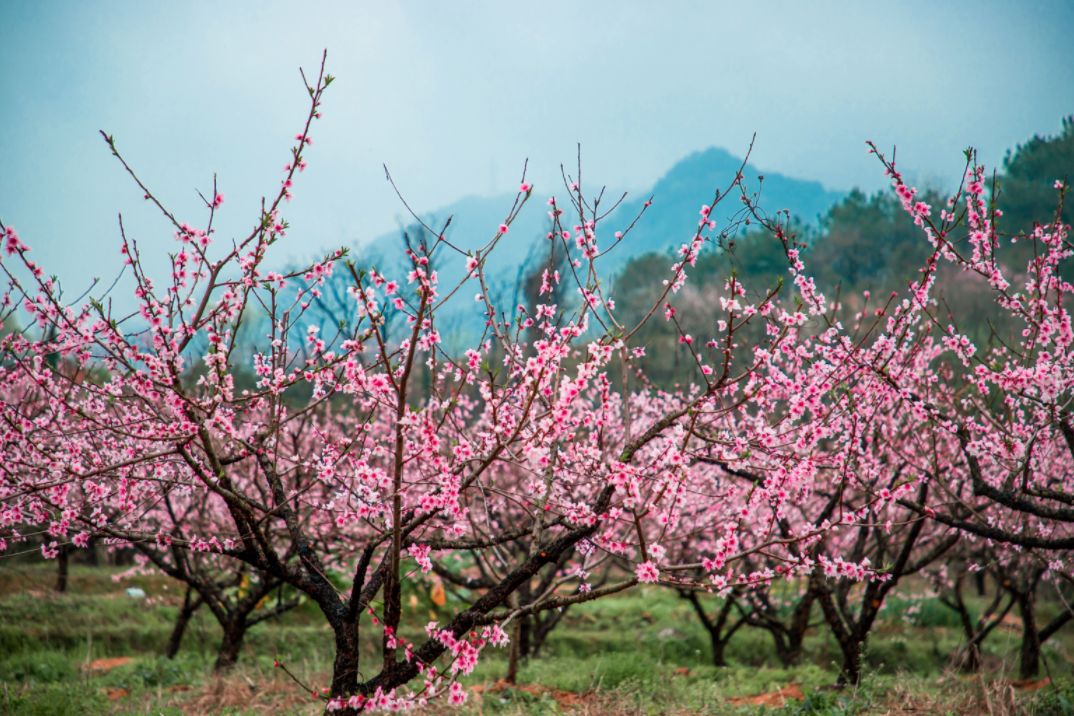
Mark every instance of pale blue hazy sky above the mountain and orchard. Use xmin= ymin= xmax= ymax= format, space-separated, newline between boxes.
xmin=0 ymin=0 xmax=1074 ymax=284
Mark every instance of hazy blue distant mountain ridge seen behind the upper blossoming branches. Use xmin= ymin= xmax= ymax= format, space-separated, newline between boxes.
xmin=347 ymin=148 xmax=843 ymax=340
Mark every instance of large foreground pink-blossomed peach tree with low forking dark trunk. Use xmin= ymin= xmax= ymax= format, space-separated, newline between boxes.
xmin=0 ymin=53 xmax=876 ymax=711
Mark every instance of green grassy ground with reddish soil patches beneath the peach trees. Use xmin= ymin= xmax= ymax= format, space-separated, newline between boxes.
xmin=0 ymin=565 xmax=1074 ymax=716
